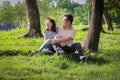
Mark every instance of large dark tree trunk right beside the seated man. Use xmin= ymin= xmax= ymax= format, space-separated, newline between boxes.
xmin=83 ymin=0 xmax=103 ymax=52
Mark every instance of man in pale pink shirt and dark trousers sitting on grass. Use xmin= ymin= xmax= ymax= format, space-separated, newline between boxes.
xmin=51 ymin=14 xmax=85 ymax=61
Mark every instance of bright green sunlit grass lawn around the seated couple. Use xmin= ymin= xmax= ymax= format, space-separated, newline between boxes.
xmin=0 ymin=26 xmax=120 ymax=80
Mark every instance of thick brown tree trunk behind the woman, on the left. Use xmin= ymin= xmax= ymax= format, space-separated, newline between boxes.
xmin=24 ymin=0 xmax=41 ymax=37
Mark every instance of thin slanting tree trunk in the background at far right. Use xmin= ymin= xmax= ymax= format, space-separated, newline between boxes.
xmin=103 ymin=8 xmax=113 ymax=31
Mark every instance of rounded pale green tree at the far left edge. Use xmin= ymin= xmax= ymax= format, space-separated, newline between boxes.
xmin=0 ymin=1 xmax=16 ymax=24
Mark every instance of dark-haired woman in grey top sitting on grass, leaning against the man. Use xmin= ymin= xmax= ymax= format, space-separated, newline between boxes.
xmin=33 ymin=18 xmax=56 ymax=53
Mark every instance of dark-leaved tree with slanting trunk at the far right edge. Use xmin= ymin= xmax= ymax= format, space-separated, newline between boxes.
xmin=103 ymin=0 xmax=120 ymax=30
